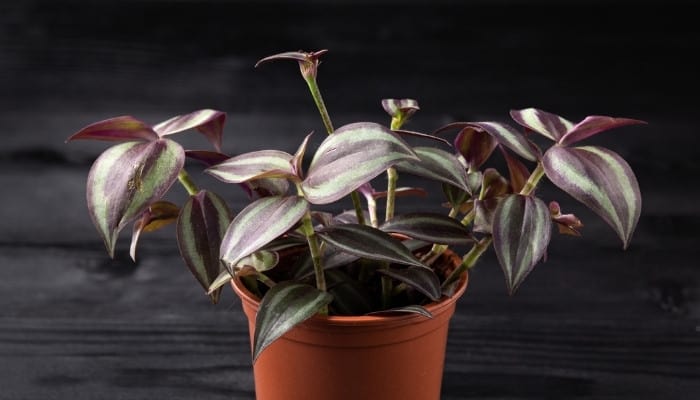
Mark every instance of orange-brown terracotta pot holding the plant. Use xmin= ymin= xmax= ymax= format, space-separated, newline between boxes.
xmin=232 ymin=252 xmax=467 ymax=400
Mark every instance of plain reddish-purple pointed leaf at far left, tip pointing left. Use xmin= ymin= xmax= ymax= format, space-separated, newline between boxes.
xmin=66 ymin=116 xmax=158 ymax=142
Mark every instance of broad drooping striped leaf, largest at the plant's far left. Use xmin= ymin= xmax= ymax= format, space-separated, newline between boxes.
xmin=87 ymin=139 xmax=185 ymax=257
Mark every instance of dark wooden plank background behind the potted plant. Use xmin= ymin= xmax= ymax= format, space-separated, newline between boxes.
xmin=0 ymin=0 xmax=700 ymax=400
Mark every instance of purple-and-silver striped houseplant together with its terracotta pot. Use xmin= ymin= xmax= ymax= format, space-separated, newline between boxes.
xmin=69 ymin=51 xmax=643 ymax=400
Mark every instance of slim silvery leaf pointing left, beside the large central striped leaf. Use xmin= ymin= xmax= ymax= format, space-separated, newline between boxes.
xmin=205 ymin=150 xmax=295 ymax=183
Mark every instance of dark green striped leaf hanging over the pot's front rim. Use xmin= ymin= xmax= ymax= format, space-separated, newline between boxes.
xmin=253 ymin=281 xmax=333 ymax=362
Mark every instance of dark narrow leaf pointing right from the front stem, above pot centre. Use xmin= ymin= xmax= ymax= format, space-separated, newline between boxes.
xmin=318 ymin=224 xmax=424 ymax=267
